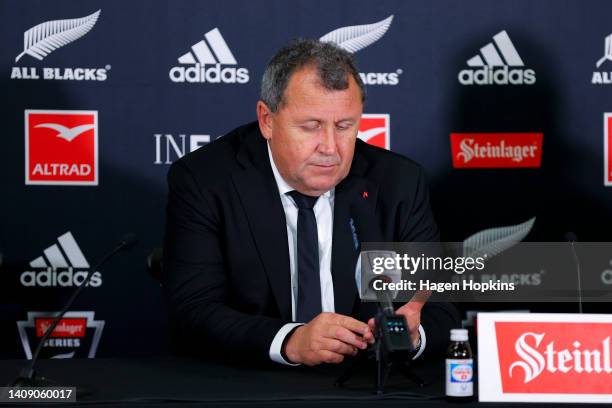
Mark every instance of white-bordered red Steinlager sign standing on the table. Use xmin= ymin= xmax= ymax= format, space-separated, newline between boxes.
xmin=478 ymin=312 xmax=612 ymax=405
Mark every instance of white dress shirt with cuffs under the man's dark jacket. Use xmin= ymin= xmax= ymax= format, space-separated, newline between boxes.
xmin=268 ymin=145 xmax=425 ymax=365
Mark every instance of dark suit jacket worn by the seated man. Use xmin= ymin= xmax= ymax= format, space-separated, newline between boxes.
xmin=162 ymin=122 xmax=458 ymax=361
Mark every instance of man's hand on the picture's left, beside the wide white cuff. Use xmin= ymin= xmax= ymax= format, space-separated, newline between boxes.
xmin=283 ymin=312 xmax=374 ymax=366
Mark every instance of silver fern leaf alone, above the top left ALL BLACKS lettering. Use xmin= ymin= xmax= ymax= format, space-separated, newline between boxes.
xmin=15 ymin=10 xmax=101 ymax=62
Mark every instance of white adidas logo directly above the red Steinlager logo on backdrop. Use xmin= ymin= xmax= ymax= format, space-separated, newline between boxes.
xmin=458 ymin=30 xmax=536 ymax=85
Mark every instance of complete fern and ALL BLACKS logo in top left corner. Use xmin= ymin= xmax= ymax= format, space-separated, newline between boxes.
xmin=11 ymin=10 xmax=111 ymax=81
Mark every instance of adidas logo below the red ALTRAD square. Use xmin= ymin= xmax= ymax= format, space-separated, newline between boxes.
xmin=20 ymin=231 xmax=102 ymax=287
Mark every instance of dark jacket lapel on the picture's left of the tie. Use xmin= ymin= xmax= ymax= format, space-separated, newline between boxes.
xmin=232 ymin=132 xmax=292 ymax=320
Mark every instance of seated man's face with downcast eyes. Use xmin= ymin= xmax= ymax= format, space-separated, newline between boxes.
xmin=257 ymin=66 xmax=363 ymax=196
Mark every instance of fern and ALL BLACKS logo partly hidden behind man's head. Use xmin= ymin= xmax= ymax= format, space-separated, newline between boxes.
xmin=319 ymin=15 xmax=403 ymax=85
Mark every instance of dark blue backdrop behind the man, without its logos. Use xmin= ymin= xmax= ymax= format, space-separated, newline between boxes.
xmin=0 ymin=0 xmax=612 ymax=356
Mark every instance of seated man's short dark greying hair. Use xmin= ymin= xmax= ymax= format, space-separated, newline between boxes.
xmin=260 ymin=38 xmax=365 ymax=112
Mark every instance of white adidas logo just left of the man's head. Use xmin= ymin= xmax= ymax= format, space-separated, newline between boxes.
xmin=170 ymin=28 xmax=249 ymax=84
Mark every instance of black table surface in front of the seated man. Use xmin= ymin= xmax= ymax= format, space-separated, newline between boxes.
xmin=0 ymin=357 xmax=592 ymax=408
